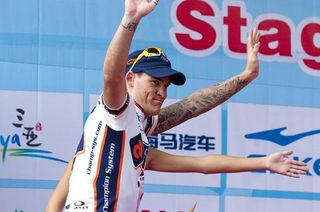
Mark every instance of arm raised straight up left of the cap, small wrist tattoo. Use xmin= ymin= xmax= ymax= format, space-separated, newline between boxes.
xmin=103 ymin=0 xmax=158 ymax=109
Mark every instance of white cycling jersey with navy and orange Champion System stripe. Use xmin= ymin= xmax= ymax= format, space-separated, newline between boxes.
xmin=65 ymin=95 xmax=157 ymax=212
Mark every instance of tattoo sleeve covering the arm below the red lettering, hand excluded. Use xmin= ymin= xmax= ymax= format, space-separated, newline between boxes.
xmin=153 ymin=76 xmax=249 ymax=134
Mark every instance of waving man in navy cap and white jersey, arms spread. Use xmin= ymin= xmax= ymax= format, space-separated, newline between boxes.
xmin=47 ymin=0 xmax=307 ymax=212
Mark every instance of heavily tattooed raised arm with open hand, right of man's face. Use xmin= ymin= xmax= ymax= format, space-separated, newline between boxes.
xmin=153 ymin=29 xmax=260 ymax=134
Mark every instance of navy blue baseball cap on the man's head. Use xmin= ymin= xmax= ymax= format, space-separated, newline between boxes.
xmin=126 ymin=47 xmax=186 ymax=85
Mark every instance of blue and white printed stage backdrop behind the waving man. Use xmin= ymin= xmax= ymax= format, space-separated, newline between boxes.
xmin=0 ymin=0 xmax=320 ymax=212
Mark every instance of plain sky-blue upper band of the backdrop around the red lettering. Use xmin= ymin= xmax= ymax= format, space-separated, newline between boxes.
xmin=0 ymin=0 xmax=320 ymax=107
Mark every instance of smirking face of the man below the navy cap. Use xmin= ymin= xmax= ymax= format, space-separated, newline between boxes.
xmin=132 ymin=72 xmax=170 ymax=115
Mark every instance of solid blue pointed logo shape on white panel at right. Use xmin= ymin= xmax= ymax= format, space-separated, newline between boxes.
xmin=244 ymin=127 xmax=320 ymax=146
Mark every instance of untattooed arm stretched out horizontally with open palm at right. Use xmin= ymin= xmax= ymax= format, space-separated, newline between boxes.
xmin=147 ymin=148 xmax=308 ymax=178
